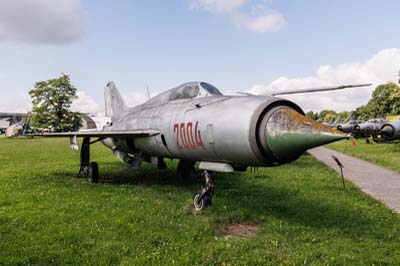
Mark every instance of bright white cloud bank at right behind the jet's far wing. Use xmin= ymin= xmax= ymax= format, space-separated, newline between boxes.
xmin=248 ymin=48 xmax=400 ymax=111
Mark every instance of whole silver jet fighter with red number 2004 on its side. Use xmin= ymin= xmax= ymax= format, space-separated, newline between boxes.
xmin=34 ymin=82 xmax=372 ymax=210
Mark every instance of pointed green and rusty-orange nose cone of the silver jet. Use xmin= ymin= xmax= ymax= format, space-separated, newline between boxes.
xmin=265 ymin=107 xmax=347 ymax=162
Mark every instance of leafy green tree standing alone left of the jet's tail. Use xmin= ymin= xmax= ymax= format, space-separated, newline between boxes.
xmin=29 ymin=74 xmax=81 ymax=132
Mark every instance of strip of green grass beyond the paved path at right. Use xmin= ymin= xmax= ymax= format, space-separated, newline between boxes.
xmin=327 ymin=139 xmax=400 ymax=171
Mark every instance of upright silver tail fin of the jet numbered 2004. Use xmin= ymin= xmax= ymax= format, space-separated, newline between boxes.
xmin=104 ymin=81 xmax=128 ymax=117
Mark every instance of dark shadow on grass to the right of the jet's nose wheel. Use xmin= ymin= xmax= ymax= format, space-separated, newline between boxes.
xmin=217 ymin=176 xmax=378 ymax=236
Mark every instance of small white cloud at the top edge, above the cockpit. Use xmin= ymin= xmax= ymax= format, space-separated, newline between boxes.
xmin=191 ymin=0 xmax=287 ymax=33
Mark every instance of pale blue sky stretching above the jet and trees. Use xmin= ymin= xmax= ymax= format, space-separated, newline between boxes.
xmin=0 ymin=0 xmax=400 ymax=111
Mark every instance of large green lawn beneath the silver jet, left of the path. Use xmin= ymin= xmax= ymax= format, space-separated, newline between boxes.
xmin=0 ymin=138 xmax=400 ymax=265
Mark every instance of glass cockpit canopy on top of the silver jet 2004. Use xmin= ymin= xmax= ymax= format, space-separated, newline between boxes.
xmin=170 ymin=82 xmax=222 ymax=101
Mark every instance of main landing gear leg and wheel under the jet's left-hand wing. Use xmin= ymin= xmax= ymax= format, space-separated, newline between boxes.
xmin=78 ymin=137 xmax=99 ymax=183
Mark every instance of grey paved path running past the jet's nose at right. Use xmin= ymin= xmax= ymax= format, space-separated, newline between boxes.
xmin=308 ymin=147 xmax=400 ymax=213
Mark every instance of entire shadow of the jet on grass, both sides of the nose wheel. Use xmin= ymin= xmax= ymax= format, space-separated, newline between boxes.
xmin=45 ymin=159 xmax=382 ymax=238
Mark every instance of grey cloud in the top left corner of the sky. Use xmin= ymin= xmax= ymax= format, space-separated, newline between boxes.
xmin=0 ymin=0 xmax=85 ymax=44
